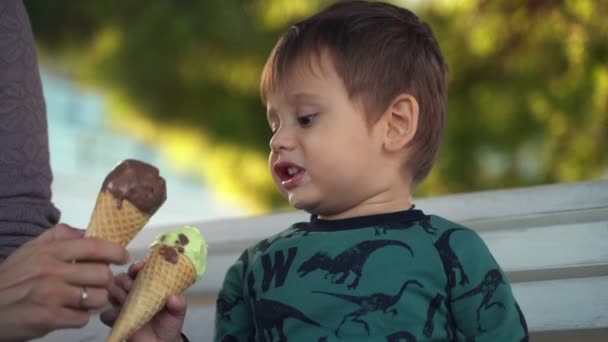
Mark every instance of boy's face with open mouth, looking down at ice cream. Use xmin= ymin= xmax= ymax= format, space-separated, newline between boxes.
xmin=266 ymin=53 xmax=390 ymax=218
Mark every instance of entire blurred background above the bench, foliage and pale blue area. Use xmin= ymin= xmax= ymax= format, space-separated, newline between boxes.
xmin=25 ymin=0 xmax=608 ymax=226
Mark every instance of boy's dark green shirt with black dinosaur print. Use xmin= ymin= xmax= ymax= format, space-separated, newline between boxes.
xmin=215 ymin=210 xmax=528 ymax=342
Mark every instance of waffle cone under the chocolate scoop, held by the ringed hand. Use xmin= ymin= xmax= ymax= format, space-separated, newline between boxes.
xmin=85 ymin=191 xmax=150 ymax=247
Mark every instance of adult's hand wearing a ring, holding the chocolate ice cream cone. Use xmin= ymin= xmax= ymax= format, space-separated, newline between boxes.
xmin=0 ymin=224 xmax=128 ymax=341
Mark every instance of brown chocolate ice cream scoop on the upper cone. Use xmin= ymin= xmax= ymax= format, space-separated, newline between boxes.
xmin=101 ymin=159 xmax=167 ymax=215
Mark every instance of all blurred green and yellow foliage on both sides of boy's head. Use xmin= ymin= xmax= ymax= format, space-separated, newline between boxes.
xmin=26 ymin=0 xmax=608 ymax=210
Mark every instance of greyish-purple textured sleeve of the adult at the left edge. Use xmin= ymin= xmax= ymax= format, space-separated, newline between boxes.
xmin=0 ymin=0 xmax=59 ymax=260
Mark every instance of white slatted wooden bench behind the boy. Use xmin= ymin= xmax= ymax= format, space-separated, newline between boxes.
xmin=41 ymin=181 xmax=608 ymax=342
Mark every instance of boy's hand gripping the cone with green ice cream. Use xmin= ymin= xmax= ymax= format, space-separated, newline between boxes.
xmin=101 ymin=261 xmax=186 ymax=342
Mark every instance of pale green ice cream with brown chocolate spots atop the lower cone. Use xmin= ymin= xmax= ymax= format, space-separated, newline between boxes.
xmin=150 ymin=226 xmax=207 ymax=280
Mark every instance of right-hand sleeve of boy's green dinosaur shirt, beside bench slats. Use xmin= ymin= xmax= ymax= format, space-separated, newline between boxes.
xmin=448 ymin=229 xmax=528 ymax=342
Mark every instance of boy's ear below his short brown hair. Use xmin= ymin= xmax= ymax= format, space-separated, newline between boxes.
xmin=384 ymin=94 xmax=419 ymax=152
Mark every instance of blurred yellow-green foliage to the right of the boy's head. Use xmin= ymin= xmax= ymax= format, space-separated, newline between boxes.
xmin=424 ymin=0 xmax=608 ymax=192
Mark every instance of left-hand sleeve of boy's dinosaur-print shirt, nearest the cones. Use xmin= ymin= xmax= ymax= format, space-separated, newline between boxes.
xmin=214 ymin=251 xmax=255 ymax=342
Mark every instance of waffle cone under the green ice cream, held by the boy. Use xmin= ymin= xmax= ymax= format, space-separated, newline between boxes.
xmin=107 ymin=245 xmax=196 ymax=342
